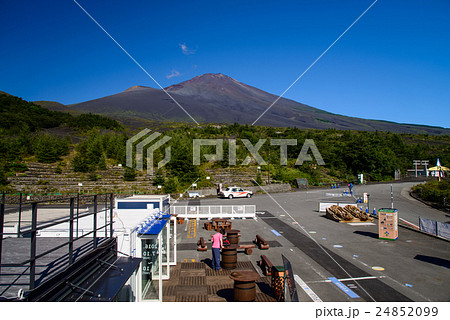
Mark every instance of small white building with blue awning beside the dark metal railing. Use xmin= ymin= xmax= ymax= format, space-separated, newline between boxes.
xmin=39 ymin=195 xmax=176 ymax=301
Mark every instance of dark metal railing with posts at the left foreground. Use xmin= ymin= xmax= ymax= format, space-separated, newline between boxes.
xmin=0 ymin=194 xmax=114 ymax=290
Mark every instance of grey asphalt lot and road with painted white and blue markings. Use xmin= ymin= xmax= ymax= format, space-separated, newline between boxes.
xmin=177 ymin=183 xmax=450 ymax=301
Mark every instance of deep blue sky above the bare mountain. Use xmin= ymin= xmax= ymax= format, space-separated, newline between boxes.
xmin=0 ymin=0 xmax=450 ymax=128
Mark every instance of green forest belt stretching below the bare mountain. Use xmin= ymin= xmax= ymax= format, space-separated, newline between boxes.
xmin=0 ymin=94 xmax=450 ymax=192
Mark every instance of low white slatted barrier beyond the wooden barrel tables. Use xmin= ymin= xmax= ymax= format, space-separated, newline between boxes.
xmin=170 ymin=205 xmax=256 ymax=220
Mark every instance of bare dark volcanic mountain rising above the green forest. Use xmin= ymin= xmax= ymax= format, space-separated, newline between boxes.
xmin=70 ymin=73 xmax=450 ymax=134
